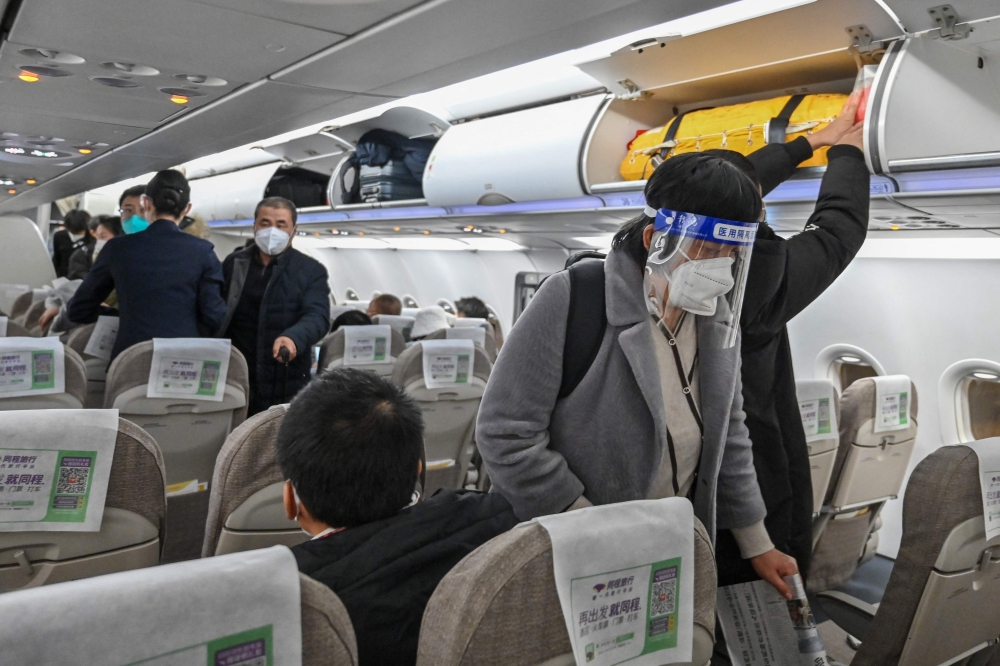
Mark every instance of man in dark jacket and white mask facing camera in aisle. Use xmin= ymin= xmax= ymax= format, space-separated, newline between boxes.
xmin=221 ymin=197 xmax=330 ymax=415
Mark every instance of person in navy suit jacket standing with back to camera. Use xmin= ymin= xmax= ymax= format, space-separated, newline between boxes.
xmin=67 ymin=171 xmax=226 ymax=359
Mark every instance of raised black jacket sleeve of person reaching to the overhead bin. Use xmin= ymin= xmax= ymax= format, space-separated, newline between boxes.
xmin=740 ymin=144 xmax=870 ymax=342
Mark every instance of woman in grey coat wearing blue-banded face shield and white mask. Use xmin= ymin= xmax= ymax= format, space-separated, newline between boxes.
xmin=476 ymin=153 xmax=797 ymax=596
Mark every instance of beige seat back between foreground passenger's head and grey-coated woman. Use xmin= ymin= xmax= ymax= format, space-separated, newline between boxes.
xmin=392 ymin=342 xmax=493 ymax=497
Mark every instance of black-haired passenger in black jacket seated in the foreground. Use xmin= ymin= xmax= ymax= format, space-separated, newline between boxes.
xmin=276 ymin=368 xmax=517 ymax=666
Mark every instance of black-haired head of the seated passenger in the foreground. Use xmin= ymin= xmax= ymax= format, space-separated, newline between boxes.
xmin=275 ymin=367 xmax=424 ymax=535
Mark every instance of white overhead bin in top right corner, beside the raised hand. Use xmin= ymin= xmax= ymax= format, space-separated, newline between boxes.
xmin=865 ymin=0 xmax=1000 ymax=174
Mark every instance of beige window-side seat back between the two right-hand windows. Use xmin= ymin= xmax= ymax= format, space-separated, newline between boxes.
xmin=806 ymin=378 xmax=919 ymax=592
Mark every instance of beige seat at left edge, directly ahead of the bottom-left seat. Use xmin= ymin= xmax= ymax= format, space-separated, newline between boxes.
xmin=0 ymin=418 xmax=167 ymax=593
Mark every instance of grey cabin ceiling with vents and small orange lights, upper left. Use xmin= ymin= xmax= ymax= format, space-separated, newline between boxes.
xmin=0 ymin=0 xmax=726 ymax=212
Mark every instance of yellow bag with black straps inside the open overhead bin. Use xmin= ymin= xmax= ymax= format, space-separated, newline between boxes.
xmin=621 ymin=95 xmax=848 ymax=180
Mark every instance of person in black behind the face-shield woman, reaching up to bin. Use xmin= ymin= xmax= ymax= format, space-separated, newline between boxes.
xmin=716 ymin=97 xmax=870 ymax=585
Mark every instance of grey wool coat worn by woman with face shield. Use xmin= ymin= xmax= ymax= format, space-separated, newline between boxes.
xmin=476 ymin=250 xmax=765 ymax=542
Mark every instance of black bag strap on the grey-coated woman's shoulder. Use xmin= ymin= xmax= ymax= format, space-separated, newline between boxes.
xmin=559 ymin=259 xmax=608 ymax=400
